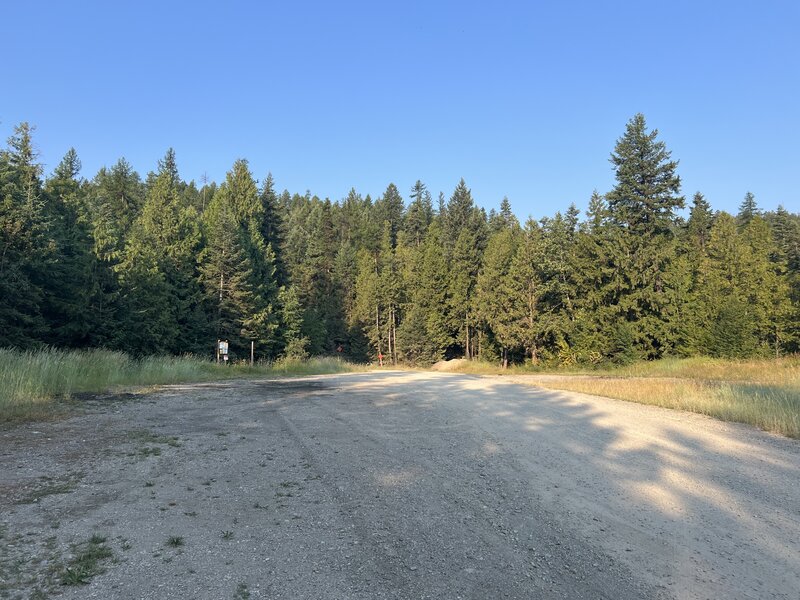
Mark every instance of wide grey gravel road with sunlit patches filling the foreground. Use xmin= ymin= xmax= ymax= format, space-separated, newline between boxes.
xmin=0 ymin=372 xmax=800 ymax=600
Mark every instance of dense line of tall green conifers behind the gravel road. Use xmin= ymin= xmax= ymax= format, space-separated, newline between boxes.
xmin=0 ymin=115 xmax=800 ymax=364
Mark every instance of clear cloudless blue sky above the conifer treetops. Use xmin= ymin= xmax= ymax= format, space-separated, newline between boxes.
xmin=0 ymin=1 xmax=800 ymax=218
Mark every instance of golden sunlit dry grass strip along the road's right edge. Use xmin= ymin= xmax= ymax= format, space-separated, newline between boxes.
xmin=432 ymin=356 xmax=800 ymax=439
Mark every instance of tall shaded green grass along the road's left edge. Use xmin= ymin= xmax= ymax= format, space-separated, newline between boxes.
xmin=0 ymin=349 xmax=359 ymax=423
